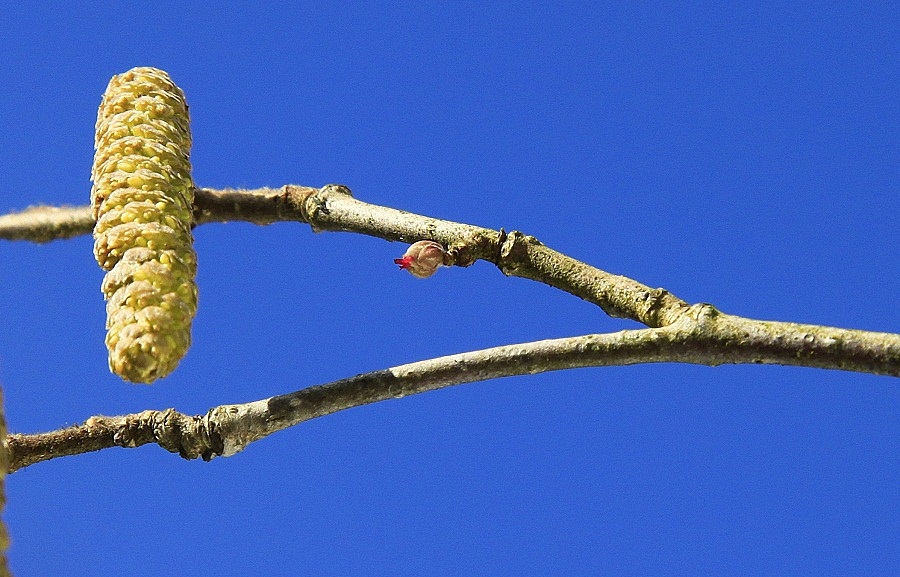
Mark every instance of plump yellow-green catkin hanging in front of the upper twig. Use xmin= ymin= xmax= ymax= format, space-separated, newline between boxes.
xmin=91 ymin=68 xmax=197 ymax=383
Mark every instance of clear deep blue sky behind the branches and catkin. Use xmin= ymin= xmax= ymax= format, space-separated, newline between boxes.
xmin=0 ymin=2 xmax=900 ymax=576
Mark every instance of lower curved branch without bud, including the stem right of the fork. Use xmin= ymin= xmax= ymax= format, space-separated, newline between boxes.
xmin=8 ymin=318 xmax=900 ymax=472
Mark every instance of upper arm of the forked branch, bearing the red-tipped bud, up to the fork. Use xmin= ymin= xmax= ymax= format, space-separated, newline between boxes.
xmin=0 ymin=185 xmax=688 ymax=327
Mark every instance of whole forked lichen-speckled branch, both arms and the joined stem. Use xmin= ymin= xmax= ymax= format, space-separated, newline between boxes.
xmin=0 ymin=185 xmax=900 ymax=471
